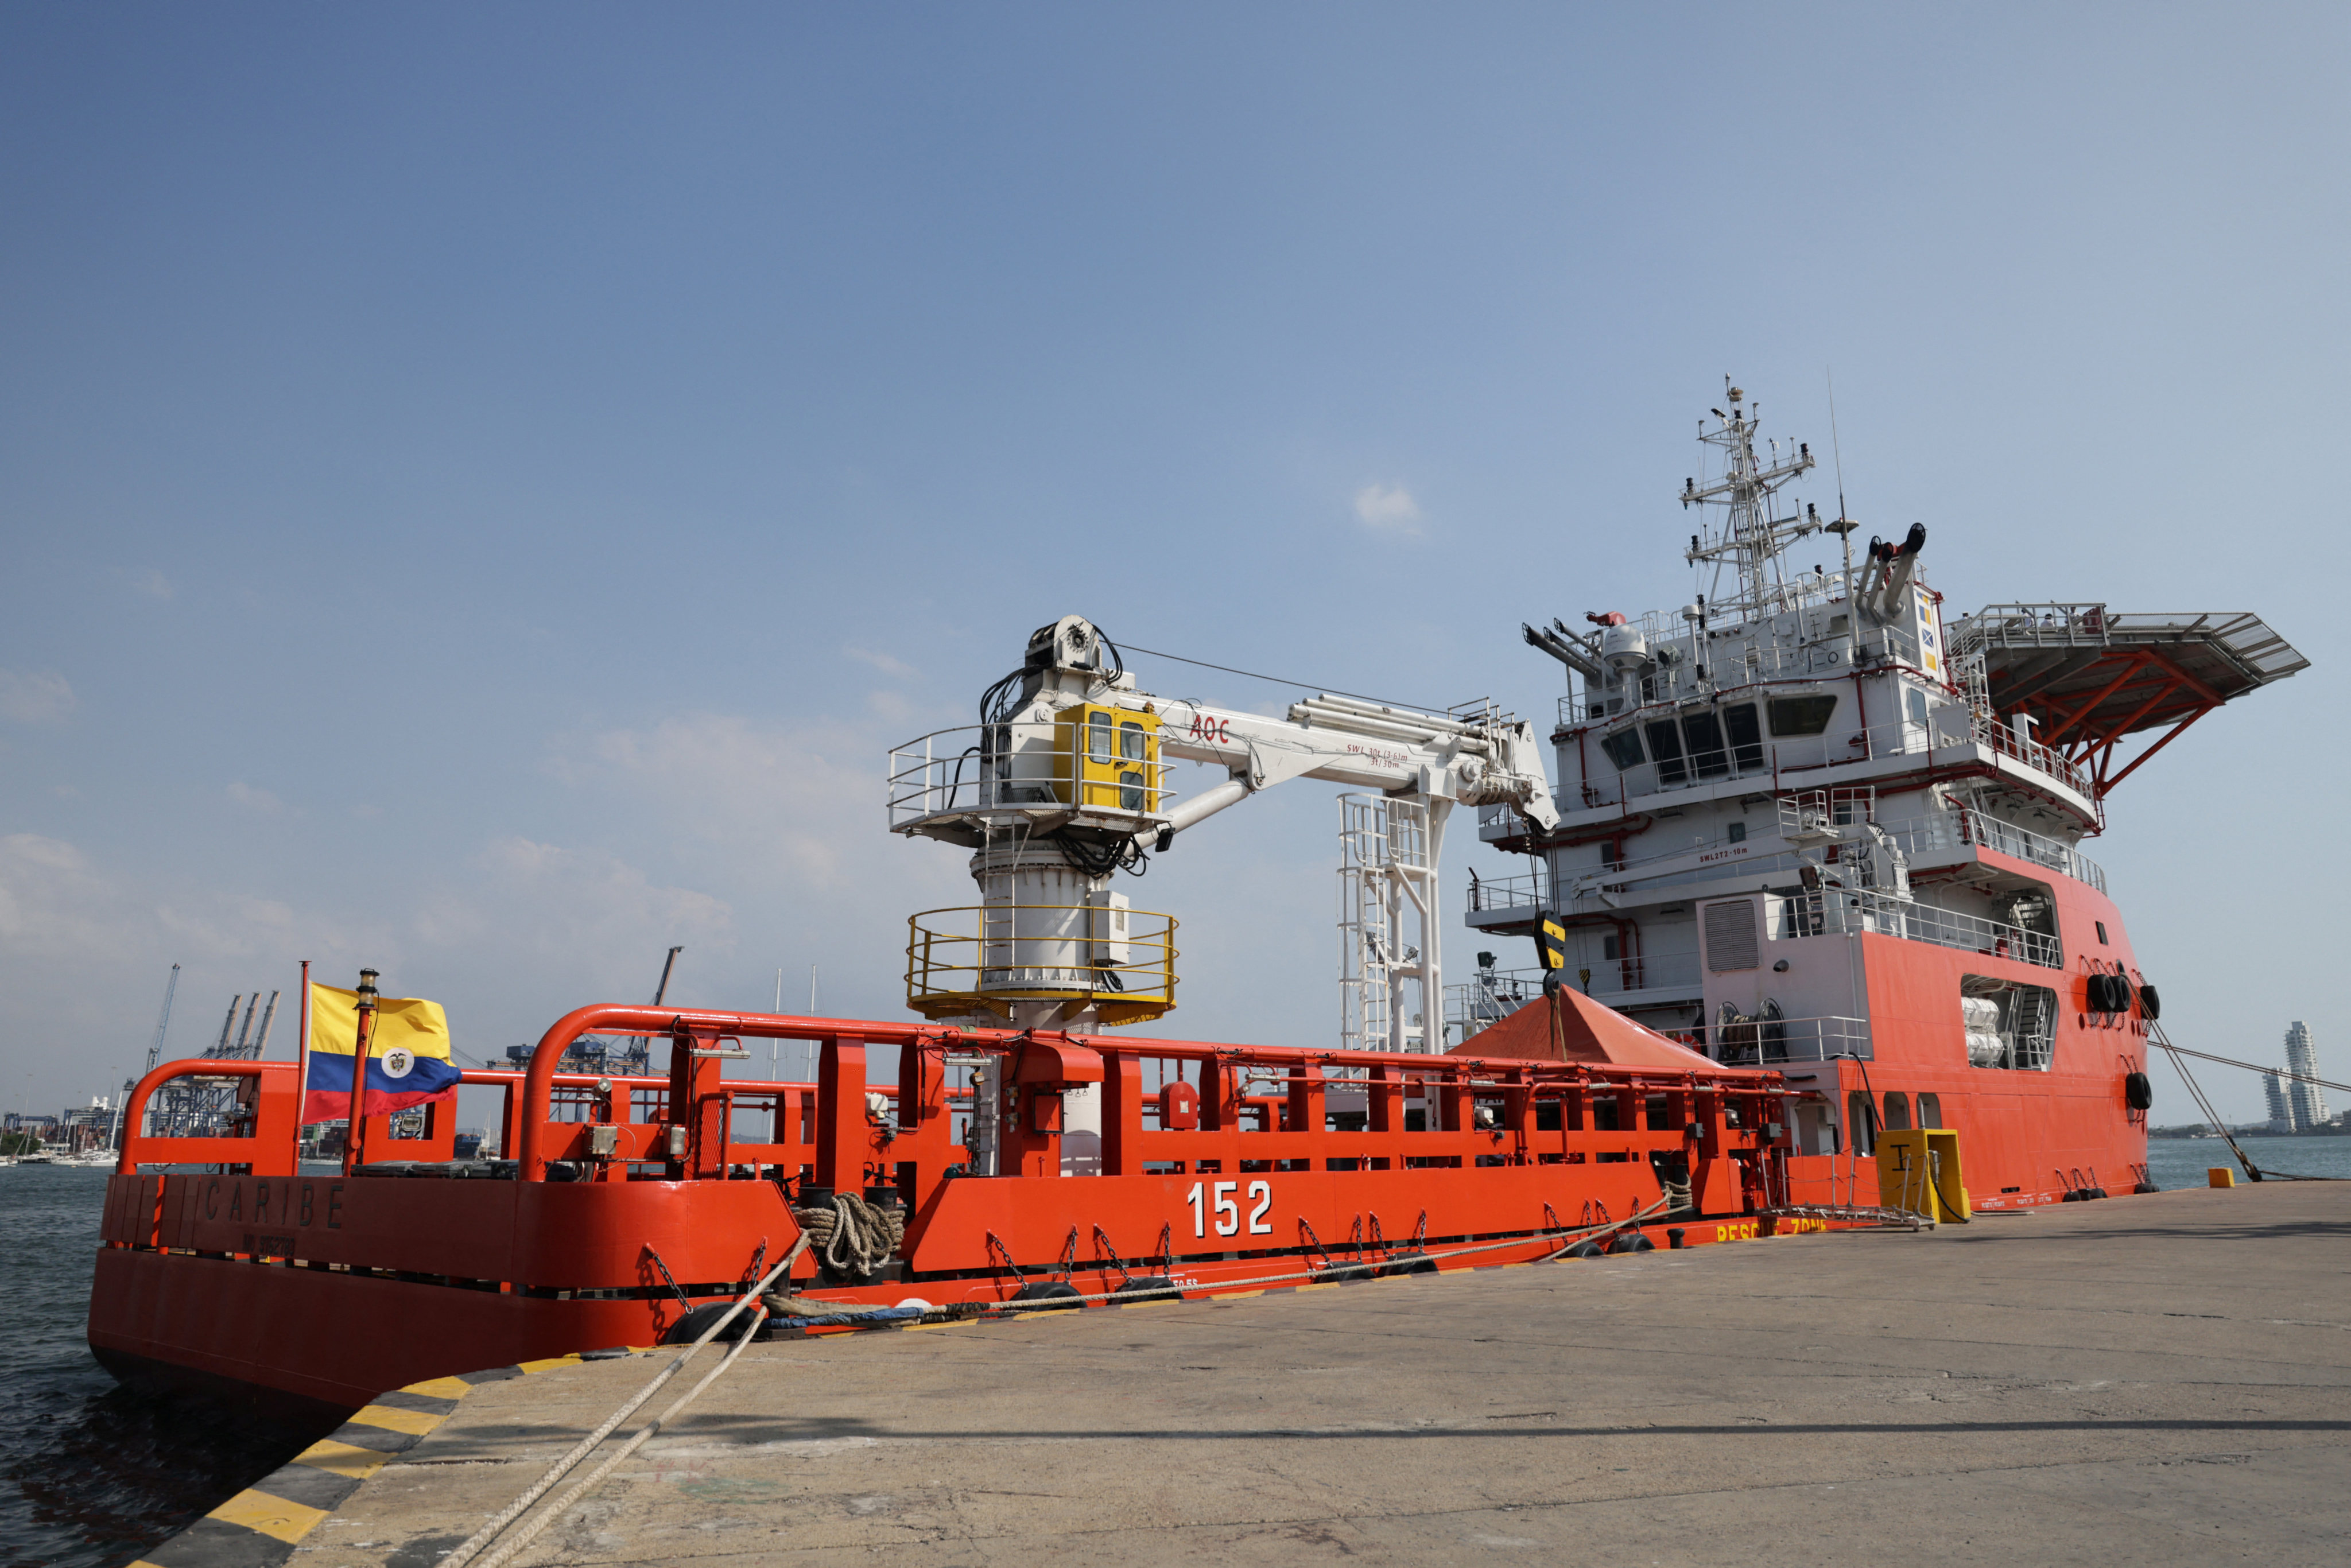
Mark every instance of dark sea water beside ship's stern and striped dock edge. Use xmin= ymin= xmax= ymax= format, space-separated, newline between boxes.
xmin=0 ymin=1166 xmax=320 ymax=1568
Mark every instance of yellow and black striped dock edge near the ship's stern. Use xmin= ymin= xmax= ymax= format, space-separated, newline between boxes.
xmin=129 ymin=1356 xmax=597 ymax=1568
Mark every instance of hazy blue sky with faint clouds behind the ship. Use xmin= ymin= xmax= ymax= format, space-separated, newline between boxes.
xmin=0 ymin=5 xmax=2351 ymax=1119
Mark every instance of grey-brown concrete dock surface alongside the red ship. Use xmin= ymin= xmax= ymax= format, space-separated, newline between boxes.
xmin=170 ymin=1182 xmax=2351 ymax=1568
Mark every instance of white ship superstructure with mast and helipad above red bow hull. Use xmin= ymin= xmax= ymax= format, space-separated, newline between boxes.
xmin=1450 ymin=386 xmax=2306 ymax=1206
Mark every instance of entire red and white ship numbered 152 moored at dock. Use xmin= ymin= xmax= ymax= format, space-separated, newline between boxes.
xmin=90 ymin=388 xmax=2304 ymax=1413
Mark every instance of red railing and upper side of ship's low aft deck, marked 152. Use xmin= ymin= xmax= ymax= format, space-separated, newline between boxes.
xmin=106 ymin=1006 xmax=1782 ymax=1293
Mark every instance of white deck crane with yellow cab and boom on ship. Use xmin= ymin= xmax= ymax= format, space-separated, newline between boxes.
xmin=889 ymin=616 xmax=1559 ymax=1049
